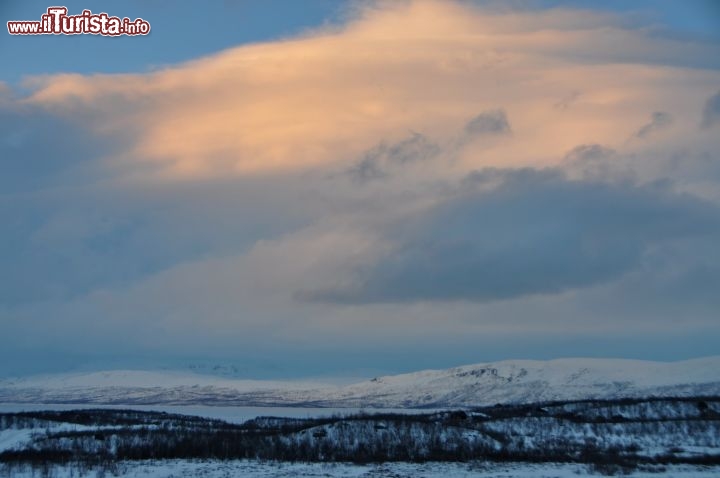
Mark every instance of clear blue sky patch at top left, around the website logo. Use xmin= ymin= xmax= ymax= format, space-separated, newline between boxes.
xmin=0 ymin=0 xmax=343 ymax=82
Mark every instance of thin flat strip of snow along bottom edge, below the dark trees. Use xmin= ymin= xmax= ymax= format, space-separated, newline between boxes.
xmin=1 ymin=460 xmax=720 ymax=478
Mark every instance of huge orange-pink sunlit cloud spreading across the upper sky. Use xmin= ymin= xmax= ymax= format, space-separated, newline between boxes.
xmin=12 ymin=1 xmax=720 ymax=180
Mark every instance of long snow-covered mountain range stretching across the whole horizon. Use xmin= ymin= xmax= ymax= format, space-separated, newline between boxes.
xmin=0 ymin=356 xmax=720 ymax=408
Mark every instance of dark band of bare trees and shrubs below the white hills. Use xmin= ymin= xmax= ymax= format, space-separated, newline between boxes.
xmin=0 ymin=397 xmax=720 ymax=474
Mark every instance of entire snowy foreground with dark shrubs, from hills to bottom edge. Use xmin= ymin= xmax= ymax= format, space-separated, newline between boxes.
xmin=0 ymin=397 xmax=720 ymax=477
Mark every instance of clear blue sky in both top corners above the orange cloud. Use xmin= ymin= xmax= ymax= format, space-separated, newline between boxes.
xmin=0 ymin=0 xmax=720 ymax=82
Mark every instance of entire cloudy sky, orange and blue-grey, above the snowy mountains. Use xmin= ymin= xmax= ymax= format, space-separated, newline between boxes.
xmin=0 ymin=0 xmax=720 ymax=378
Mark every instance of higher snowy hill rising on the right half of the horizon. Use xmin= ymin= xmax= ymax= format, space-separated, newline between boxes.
xmin=316 ymin=357 xmax=720 ymax=407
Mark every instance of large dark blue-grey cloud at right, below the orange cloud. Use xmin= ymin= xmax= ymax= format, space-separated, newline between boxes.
xmin=301 ymin=169 xmax=720 ymax=303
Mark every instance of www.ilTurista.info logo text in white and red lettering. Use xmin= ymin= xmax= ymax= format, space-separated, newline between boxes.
xmin=8 ymin=7 xmax=150 ymax=36
